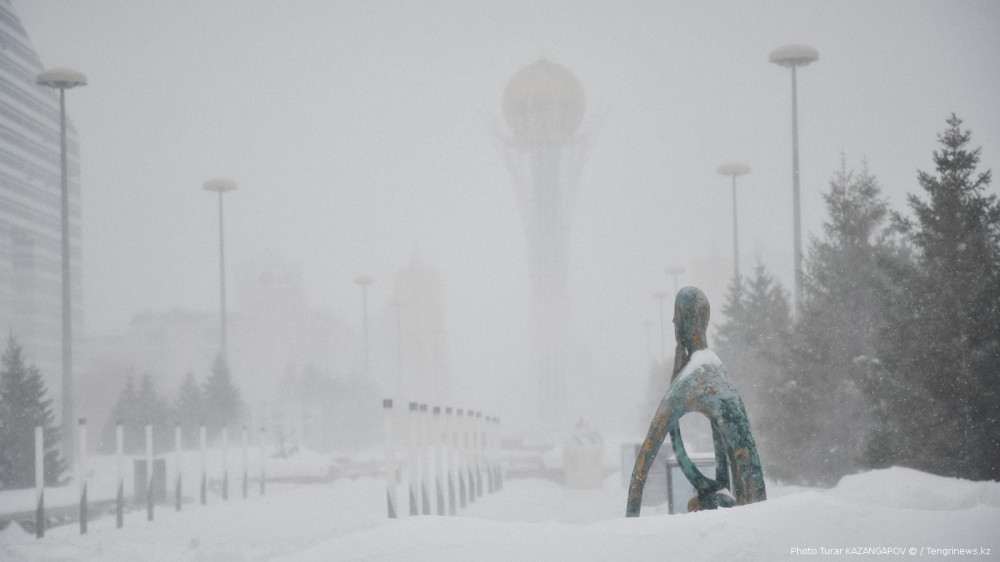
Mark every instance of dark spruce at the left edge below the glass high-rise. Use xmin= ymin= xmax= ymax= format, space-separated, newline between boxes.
xmin=0 ymin=333 xmax=66 ymax=489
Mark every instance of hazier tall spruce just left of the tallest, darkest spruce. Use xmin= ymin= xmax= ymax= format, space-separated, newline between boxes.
xmin=790 ymin=157 xmax=894 ymax=485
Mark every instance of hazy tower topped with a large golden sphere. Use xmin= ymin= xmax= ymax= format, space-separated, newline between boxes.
xmin=501 ymin=59 xmax=584 ymax=431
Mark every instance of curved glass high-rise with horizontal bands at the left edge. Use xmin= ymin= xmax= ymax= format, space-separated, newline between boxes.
xmin=0 ymin=0 xmax=82 ymax=382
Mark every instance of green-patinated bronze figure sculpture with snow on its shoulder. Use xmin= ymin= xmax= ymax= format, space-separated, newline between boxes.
xmin=625 ymin=287 xmax=767 ymax=517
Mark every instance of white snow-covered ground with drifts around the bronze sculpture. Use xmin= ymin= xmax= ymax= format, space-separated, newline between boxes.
xmin=0 ymin=450 xmax=1000 ymax=562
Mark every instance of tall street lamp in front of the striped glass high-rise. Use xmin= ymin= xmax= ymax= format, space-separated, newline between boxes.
xmin=36 ymin=68 xmax=87 ymax=463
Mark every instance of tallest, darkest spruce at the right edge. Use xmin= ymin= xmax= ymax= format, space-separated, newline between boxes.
xmin=883 ymin=114 xmax=1000 ymax=480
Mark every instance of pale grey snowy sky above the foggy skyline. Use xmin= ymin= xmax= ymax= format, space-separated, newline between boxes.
xmin=14 ymin=0 xmax=1000 ymax=420
